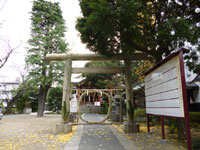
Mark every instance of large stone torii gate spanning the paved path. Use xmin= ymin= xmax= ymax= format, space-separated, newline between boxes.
xmin=46 ymin=53 xmax=149 ymax=132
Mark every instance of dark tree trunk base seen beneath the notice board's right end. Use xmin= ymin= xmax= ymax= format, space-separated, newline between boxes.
xmin=177 ymin=119 xmax=187 ymax=140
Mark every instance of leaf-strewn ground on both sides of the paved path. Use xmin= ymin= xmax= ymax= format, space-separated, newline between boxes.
xmin=0 ymin=115 xmax=200 ymax=150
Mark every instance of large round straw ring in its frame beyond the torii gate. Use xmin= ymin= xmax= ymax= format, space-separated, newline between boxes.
xmin=70 ymin=89 xmax=123 ymax=124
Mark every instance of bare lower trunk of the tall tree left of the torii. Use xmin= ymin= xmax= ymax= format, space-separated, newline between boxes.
xmin=37 ymin=85 xmax=50 ymax=117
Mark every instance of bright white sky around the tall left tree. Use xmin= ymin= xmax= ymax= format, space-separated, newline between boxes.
xmin=0 ymin=0 xmax=91 ymax=81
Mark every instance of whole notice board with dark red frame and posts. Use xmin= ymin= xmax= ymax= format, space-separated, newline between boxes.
xmin=145 ymin=49 xmax=192 ymax=150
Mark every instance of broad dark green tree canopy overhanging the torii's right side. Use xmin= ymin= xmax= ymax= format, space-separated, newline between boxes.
xmin=76 ymin=0 xmax=199 ymax=61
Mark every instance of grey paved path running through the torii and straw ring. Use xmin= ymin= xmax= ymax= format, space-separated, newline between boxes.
xmin=65 ymin=114 xmax=137 ymax=150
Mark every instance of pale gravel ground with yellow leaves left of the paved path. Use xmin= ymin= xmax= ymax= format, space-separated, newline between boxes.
xmin=0 ymin=114 xmax=72 ymax=150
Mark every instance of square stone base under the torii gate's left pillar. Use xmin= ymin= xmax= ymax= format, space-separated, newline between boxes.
xmin=56 ymin=123 xmax=72 ymax=134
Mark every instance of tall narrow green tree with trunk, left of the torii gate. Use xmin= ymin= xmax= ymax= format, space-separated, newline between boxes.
xmin=26 ymin=0 xmax=67 ymax=116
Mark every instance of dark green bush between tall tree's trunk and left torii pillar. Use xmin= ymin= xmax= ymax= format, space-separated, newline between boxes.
xmin=47 ymin=87 xmax=63 ymax=112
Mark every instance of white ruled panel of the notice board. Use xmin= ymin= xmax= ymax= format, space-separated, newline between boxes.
xmin=145 ymin=55 xmax=184 ymax=117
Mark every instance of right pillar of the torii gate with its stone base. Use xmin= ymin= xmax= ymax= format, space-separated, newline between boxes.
xmin=124 ymin=60 xmax=139 ymax=133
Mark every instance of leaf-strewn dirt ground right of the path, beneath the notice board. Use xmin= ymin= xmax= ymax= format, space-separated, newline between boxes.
xmin=113 ymin=123 xmax=200 ymax=150
